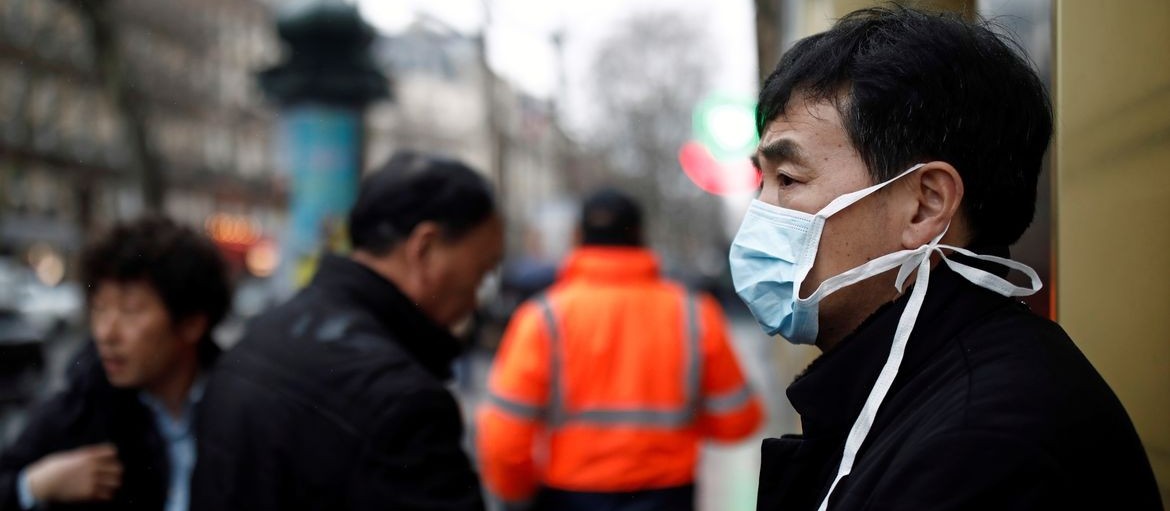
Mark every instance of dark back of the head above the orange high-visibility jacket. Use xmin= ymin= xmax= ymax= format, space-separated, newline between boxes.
xmin=580 ymin=188 xmax=642 ymax=247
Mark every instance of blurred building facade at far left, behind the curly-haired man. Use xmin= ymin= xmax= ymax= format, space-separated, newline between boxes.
xmin=0 ymin=0 xmax=282 ymax=274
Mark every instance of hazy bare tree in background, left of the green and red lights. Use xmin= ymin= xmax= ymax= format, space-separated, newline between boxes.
xmin=591 ymin=12 xmax=724 ymax=271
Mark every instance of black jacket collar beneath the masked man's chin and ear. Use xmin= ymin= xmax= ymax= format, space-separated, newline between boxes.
xmin=787 ymin=244 xmax=1006 ymax=439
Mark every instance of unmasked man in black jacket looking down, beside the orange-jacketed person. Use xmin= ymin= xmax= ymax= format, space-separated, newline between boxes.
xmin=192 ymin=153 xmax=502 ymax=511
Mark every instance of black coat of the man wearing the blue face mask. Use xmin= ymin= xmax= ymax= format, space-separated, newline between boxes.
xmin=758 ymin=254 xmax=1162 ymax=511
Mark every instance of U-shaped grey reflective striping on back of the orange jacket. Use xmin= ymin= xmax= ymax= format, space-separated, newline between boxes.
xmin=535 ymin=291 xmax=703 ymax=428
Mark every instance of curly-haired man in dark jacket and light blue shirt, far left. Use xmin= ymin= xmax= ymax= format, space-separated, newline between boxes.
xmin=0 ymin=217 xmax=230 ymax=511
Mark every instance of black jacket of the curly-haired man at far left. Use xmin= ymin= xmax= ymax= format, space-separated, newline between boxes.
xmin=0 ymin=339 xmax=220 ymax=511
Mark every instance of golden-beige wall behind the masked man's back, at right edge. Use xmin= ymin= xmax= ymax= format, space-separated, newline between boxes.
xmin=1053 ymin=0 xmax=1170 ymax=502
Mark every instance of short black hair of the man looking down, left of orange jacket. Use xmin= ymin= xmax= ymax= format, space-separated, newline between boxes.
xmin=350 ymin=151 xmax=496 ymax=255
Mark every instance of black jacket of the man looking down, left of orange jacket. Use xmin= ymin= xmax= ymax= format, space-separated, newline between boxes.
xmin=192 ymin=256 xmax=483 ymax=511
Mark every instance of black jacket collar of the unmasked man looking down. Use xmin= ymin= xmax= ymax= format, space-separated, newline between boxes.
xmin=309 ymin=255 xmax=462 ymax=380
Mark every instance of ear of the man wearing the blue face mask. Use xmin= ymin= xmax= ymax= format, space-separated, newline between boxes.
xmin=902 ymin=161 xmax=969 ymax=249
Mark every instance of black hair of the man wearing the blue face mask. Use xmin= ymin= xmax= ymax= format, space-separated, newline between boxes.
xmin=756 ymin=7 xmax=1052 ymax=246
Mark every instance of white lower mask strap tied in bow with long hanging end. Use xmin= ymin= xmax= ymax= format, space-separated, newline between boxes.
xmin=810 ymin=237 xmax=1042 ymax=511
